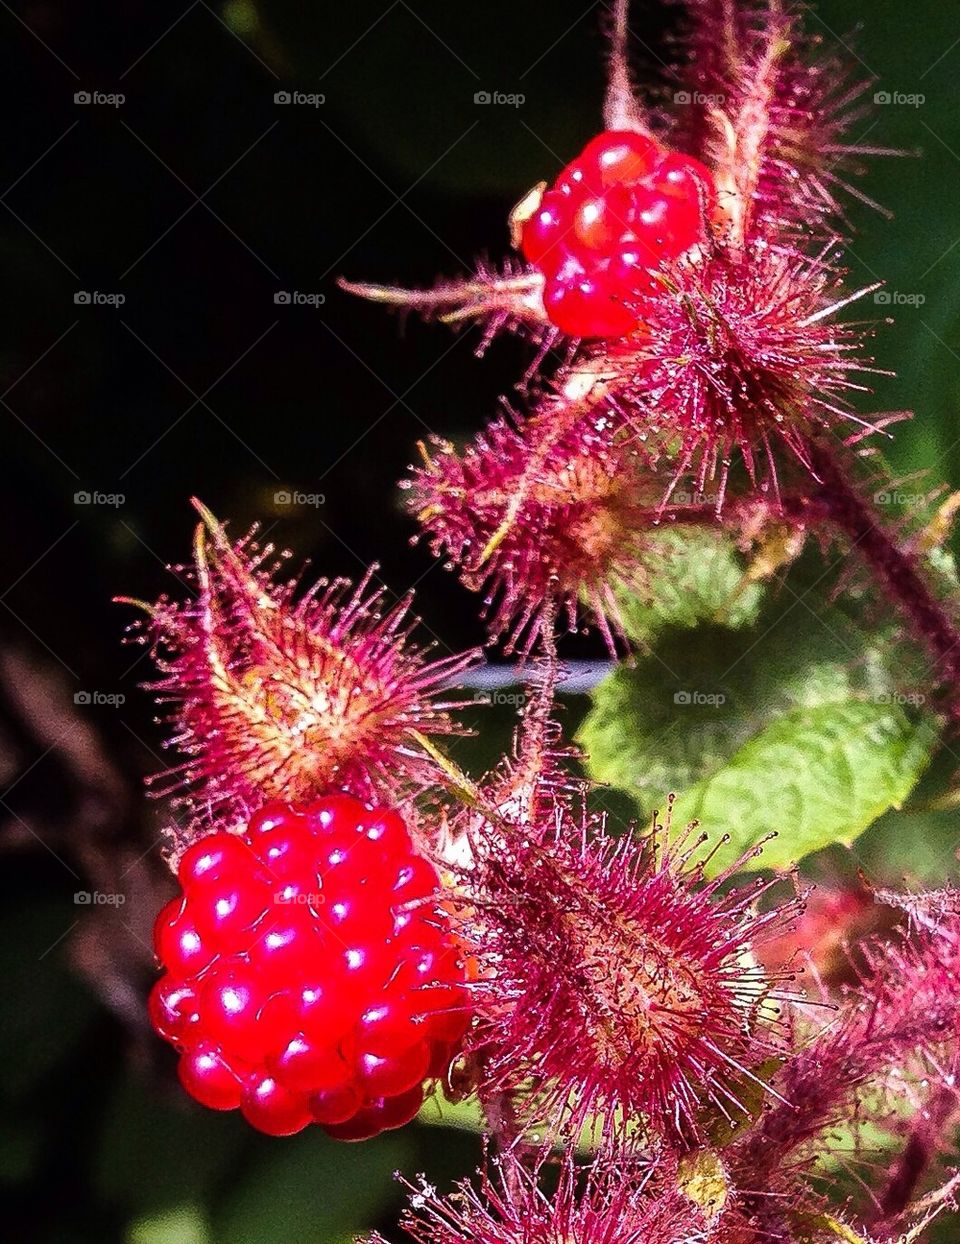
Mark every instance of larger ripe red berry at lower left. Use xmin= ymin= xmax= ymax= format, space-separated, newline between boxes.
xmin=149 ymin=795 xmax=469 ymax=1141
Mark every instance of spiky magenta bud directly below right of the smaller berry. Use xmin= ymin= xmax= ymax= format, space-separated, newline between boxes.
xmin=612 ymin=243 xmax=878 ymax=510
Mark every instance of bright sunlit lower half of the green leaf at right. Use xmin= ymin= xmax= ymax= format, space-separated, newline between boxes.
xmin=674 ymin=700 xmax=936 ymax=868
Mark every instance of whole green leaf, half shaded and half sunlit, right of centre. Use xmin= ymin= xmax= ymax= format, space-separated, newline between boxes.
xmin=578 ymin=539 xmax=938 ymax=867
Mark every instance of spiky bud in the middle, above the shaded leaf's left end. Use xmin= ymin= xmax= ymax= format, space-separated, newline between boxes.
xmin=410 ymin=393 xmax=691 ymax=653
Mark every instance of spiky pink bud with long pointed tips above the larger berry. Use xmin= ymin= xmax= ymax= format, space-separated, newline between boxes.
xmin=120 ymin=505 xmax=474 ymax=824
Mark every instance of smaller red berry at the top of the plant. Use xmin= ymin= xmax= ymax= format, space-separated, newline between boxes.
xmin=521 ymin=131 xmax=716 ymax=337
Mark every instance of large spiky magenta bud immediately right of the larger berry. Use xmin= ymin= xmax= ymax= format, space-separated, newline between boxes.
xmin=460 ymin=801 xmax=796 ymax=1142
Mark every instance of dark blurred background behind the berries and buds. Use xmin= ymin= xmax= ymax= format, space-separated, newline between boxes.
xmin=0 ymin=0 xmax=960 ymax=1244
